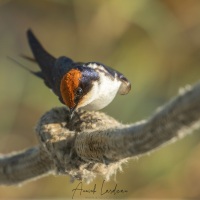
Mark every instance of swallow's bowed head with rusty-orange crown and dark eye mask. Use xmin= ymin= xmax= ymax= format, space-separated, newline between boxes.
xmin=60 ymin=64 xmax=99 ymax=116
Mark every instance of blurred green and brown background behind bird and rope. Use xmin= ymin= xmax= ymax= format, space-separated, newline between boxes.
xmin=0 ymin=0 xmax=200 ymax=199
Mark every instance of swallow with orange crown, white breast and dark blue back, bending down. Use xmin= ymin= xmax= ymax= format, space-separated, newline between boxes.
xmin=23 ymin=29 xmax=131 ymax=116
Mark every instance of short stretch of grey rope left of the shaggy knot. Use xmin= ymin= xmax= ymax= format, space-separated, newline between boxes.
xmin=0 ymin=147 xmax=53 ymax=185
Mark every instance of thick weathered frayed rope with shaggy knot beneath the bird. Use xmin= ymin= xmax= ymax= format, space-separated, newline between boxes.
xmin=0 ymin=83 xmax=200 ymax=185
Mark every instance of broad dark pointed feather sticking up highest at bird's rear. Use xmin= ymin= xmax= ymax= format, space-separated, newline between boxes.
xmin=27 ymin=29 xmax=56 ymax=74
